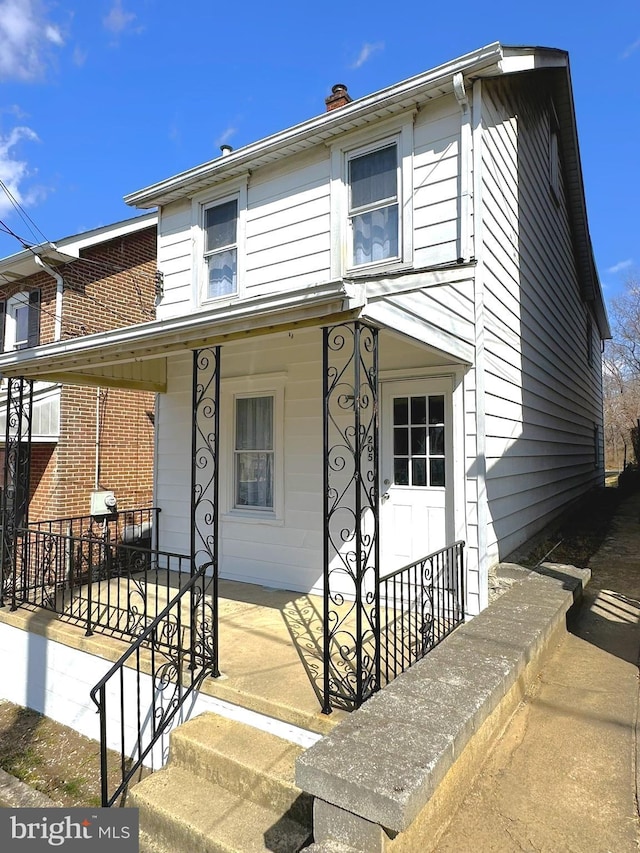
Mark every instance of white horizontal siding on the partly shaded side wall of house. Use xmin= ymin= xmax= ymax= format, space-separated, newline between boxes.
xmin=482 ymin=78 xmax=601 ymax=561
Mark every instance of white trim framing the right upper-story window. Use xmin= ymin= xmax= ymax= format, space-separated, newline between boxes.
xmin=331 ymin=114 xmax=414 ymax=278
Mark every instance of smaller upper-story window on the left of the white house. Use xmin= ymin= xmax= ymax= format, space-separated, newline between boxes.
xmin=203 ymin=198 xmax=238 ymax=299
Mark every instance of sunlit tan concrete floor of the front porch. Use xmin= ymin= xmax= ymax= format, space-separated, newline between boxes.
xmin=0 ymin=580 xmax=346 ymax=734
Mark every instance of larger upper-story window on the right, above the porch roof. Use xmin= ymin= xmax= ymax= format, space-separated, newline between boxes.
xmin=348 ymin=143 xmax=400 ymax=267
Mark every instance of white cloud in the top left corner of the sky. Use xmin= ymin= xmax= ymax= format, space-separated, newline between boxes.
xmin=0 ymin=0 xmax=64 ymax=80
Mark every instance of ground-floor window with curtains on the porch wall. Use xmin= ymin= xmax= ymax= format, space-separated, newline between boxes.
xmin=233 ymin=394 xmax=275 ymax=511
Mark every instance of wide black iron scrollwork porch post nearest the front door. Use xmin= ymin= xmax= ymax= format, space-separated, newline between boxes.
xmin=323 ymin=322 xmax=379 ymax=713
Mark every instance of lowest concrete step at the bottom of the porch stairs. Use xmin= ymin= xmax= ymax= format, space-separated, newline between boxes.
xmin=134 ymin=767 xmax=311 ymax=853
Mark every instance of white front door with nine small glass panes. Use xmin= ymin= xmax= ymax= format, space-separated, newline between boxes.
xmin=380 ymin=378 xmax=453 ymax=575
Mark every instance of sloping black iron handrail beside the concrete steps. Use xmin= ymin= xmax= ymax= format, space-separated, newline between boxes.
xmin=91 ymin=563 xmax=220 ymax=806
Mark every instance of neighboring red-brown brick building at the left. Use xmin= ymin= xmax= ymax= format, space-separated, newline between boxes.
xmin=0 ymin=214 xmax=157 ymax=521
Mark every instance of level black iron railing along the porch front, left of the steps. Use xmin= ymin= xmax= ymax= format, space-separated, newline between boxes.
xmin=4 ymin=528 xmax=192 ymax=637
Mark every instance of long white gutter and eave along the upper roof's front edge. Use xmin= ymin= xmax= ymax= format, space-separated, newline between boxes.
xmin=124 ymin=42 xmax=503 ymax=208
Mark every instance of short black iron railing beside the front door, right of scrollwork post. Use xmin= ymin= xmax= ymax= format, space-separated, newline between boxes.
xmin=379 ymin=542 xmax=465 ymax=686
